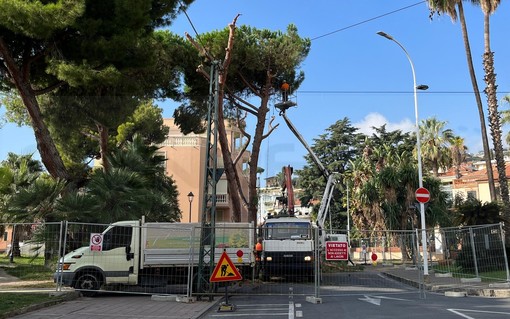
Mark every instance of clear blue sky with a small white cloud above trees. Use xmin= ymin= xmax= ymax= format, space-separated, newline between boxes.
xmin=0 ymin=0 xmax=510 ymax=181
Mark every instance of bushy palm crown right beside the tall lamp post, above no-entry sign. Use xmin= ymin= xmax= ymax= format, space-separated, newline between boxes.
xmin=420 ymin=117 xmax=453 ymax=177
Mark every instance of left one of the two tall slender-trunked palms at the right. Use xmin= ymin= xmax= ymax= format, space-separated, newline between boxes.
xmin=429 ymin=0 xmax=496 ymax=201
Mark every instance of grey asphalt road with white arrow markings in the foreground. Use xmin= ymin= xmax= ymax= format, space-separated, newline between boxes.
xmin=201 ymin=273 xmax=510 ymax=319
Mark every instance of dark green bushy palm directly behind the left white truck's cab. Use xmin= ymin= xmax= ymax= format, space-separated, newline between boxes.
xmin=58 ymin=135 xmax=181 ymax=223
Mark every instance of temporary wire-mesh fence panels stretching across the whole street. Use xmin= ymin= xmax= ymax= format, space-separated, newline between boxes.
xmin=0 ymin=222 xmax=510 ymax=300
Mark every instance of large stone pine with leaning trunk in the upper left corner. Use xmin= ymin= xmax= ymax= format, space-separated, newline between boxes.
xmin=0 ymin=0 xmax=193 ymax=179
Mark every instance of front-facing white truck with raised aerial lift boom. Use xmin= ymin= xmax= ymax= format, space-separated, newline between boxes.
xmin=260 ymin=95 xmax=347 ymax=280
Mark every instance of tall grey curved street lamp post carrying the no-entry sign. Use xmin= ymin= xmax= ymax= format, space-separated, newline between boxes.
xmin=377 ymin=31 xmax=429 ymax=276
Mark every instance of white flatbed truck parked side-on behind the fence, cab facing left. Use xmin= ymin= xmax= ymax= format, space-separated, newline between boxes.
xmin=54 ymin=221 xmax=254 ymax=295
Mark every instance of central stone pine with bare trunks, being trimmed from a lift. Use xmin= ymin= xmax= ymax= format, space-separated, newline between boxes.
xmin=174 ymin=17 xmax=310 ymax=221
